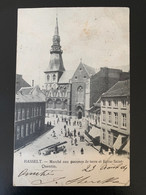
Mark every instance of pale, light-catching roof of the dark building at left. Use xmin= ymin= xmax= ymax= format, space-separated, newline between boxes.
xmin=15 ymin=86 xmax=46 ymax=103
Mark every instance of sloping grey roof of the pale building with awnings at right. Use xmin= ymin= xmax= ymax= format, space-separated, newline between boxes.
xmin=102 ymin=80 xmax=130 ymax=97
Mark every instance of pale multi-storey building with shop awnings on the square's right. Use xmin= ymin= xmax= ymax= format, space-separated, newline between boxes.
xmin=101 ymin=80 xmax=130 ymax=153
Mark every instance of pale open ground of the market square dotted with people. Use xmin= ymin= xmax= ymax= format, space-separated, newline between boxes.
xmin=15 ymin=117 xmax=100 ymax=157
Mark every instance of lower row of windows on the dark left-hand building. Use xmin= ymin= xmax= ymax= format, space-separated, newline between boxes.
xmin=16 ymin=120 xmax=41 ymax=140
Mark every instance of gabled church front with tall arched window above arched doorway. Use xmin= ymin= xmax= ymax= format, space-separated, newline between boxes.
xmin=71 ymin=62 xmax=96 ymax=119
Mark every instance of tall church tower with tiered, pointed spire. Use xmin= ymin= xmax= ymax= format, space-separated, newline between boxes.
xmin=44 ymin=17 xmax=65 ymax=90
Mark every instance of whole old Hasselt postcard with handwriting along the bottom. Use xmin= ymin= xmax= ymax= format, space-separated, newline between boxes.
xmin=13 ymin=7 xmax=130 ymax=186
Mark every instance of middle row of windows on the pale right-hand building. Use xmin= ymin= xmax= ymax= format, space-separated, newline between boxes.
xmin=102 ymin=111 xmax=127 ymax=127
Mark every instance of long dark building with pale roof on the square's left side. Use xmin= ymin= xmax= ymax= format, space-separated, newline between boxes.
xmin=14 ymin=86 xmax=46 ymax=149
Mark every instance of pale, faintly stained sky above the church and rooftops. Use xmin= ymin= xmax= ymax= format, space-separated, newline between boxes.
xmin=16 ymin=7 xmax=130 ymax=88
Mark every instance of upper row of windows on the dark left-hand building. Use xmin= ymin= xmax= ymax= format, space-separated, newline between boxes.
xmin=15 ymin=107 xmax=42 ymax=121
